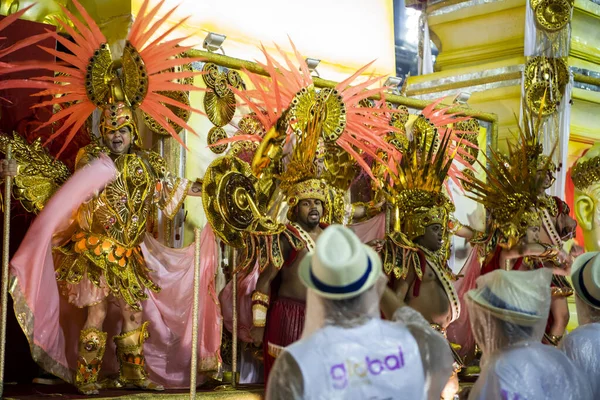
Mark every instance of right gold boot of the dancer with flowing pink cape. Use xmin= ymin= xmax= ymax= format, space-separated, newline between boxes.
xmin=113 ymin=321 xmax=164 ymax=390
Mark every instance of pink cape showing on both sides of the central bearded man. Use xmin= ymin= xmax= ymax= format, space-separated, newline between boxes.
xmin=218 ymin=213 xmax=385 ymax=343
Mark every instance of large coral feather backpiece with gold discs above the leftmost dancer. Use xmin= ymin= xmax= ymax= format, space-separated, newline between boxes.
xmin=5 ymin=0 xmax=201 ymax=154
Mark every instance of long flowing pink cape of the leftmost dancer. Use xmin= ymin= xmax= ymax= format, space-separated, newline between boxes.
xmin=10 ymin=157 xmax=222 ymax=388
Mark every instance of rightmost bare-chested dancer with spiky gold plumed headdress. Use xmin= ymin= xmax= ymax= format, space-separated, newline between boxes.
xmin=465 ymin=111 xmax=576 ymax=345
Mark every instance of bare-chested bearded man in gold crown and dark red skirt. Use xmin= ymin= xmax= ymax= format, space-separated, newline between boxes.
xmin=250 ymin=179 xmax=378 ymax=382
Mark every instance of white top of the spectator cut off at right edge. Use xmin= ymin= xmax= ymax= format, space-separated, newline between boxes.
xmin=560 ymin=323 xmax=600 ymax=399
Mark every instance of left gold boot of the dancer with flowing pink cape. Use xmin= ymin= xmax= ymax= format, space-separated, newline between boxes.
xmin=75 ymin=328 xmax=106 ymax=395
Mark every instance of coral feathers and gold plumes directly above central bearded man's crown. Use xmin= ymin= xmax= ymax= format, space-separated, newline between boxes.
xmin=216 ymin=43 xmax=397 ymax=219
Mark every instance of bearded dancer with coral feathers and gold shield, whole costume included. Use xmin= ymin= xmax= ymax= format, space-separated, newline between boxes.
xmin=203 ymin=42 xmax=394 ymax=380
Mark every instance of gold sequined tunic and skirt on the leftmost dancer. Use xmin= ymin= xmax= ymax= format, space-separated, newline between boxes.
xmin=55 ymin=145 xmax=191 ymax=309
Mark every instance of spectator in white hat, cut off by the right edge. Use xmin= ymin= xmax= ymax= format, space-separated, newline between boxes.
xmin=559 ymin=252 xmax=600 ymax=399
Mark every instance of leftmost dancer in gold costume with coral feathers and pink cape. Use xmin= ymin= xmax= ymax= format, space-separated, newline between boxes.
xmin=4 ymin=0 xmax=220 ymax=394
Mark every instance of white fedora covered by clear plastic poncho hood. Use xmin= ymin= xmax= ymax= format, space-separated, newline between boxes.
xmin=467 ymin=268 xmax=552 ymax=326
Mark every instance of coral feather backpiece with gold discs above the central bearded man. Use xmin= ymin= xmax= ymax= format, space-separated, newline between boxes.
xmin=218 ymin=39 xmax=396 ymax=186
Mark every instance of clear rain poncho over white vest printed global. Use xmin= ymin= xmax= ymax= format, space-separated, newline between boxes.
xmin=267 ymin=276 xmax=452 ymax=400
